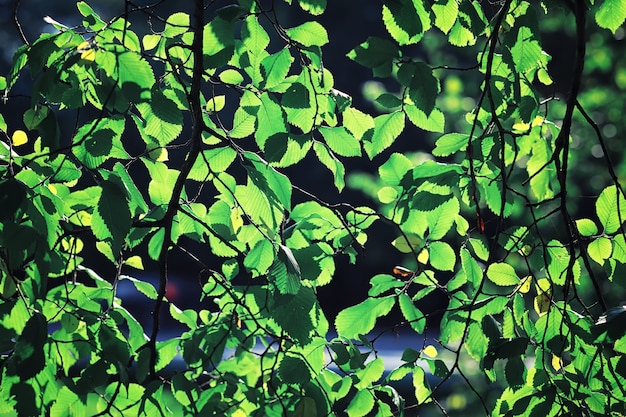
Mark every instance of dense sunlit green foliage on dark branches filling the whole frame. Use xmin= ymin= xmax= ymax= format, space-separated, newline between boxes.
xmin=0 ymin=0 xmax=626 ymax=417
